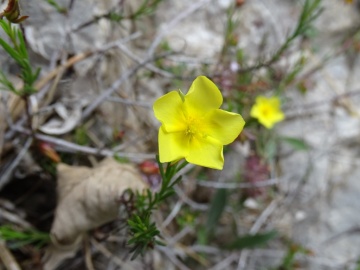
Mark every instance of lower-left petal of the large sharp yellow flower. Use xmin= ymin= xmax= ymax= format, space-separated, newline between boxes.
xmin=159 ymin=127 xmax=189 ymax=163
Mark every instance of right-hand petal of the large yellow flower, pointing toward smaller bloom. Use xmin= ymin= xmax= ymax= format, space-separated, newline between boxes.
xmin=203 ymin=109 xmax=245 ymax=145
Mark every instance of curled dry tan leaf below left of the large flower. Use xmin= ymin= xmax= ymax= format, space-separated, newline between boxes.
xmin=44 ymin=158 xmax=148 ymax=269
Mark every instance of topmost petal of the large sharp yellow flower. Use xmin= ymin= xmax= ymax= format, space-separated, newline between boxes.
xmin=185 ymin=76 xmax=223 ymax=117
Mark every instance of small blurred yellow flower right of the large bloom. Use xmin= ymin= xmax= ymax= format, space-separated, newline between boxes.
xmin=250 ymin=96 xmax=285 ymax=129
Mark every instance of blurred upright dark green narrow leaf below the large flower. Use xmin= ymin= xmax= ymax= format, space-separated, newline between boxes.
xmin=206 ymin=189 xmax=227 ymax=233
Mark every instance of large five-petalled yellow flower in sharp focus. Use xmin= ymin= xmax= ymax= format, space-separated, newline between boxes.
xmin=154 ymin=76 xmax=245 ymax=170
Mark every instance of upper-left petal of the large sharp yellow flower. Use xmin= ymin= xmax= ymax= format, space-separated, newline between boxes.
xmin=153 ymin=91 xmax=186 ymax=132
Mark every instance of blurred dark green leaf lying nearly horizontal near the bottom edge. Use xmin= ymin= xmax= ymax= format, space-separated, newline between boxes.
xmin=226 ymin=231 xmax=277 ymax=249
